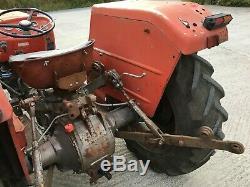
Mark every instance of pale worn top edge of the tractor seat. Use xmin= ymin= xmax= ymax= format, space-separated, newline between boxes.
xmin=9 ymin=40 xmax=95 ymax=63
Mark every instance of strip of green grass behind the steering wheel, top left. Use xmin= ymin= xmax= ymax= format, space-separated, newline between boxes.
xmin=0 ymin=0 xmax=112 ymax=11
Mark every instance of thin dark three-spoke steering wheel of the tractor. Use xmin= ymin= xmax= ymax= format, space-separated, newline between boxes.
xmin=0 ymin=8 xmax=55 ymax=38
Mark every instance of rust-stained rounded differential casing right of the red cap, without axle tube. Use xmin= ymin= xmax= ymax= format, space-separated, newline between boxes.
xmin=71 ymin=115 xmax=115 ymax=171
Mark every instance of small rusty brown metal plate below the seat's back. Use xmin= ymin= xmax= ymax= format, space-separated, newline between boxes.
xmin=57 ymin=71 xmax=87 ymax=91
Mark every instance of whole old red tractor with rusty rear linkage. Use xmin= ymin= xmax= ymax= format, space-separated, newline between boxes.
xmin=0 ymin=1 xmax=244 ymax=186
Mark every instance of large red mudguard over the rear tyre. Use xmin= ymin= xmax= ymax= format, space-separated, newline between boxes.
xmin=87 ymin=1 xmax=228 ymax=117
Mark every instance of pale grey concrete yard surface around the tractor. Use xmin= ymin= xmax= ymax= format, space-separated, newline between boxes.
xmin=46 ymin=6 xmax=250 ymax=187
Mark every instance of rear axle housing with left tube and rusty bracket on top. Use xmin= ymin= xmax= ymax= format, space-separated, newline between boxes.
xmin=39 ymin=98 xmax=116 ymax=182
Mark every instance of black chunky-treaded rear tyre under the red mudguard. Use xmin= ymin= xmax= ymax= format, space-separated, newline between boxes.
xmin=126 ymin=54 xmax=228 ymax=176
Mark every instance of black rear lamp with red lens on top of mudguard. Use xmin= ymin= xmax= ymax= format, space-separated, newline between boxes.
xmin=203 ymin=13 xmax=233 ymax=30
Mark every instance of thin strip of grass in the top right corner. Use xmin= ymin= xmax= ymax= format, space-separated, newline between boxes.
xmin=193 ymin=0 xmax=250 ymax=7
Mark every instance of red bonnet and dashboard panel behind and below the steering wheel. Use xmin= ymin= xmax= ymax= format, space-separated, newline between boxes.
xmin=0 ymin=13 xmax=55 ymax=62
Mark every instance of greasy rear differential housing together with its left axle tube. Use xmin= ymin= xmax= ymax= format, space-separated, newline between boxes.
xmin=39 ymin=115 xmax=115 ymax=179
